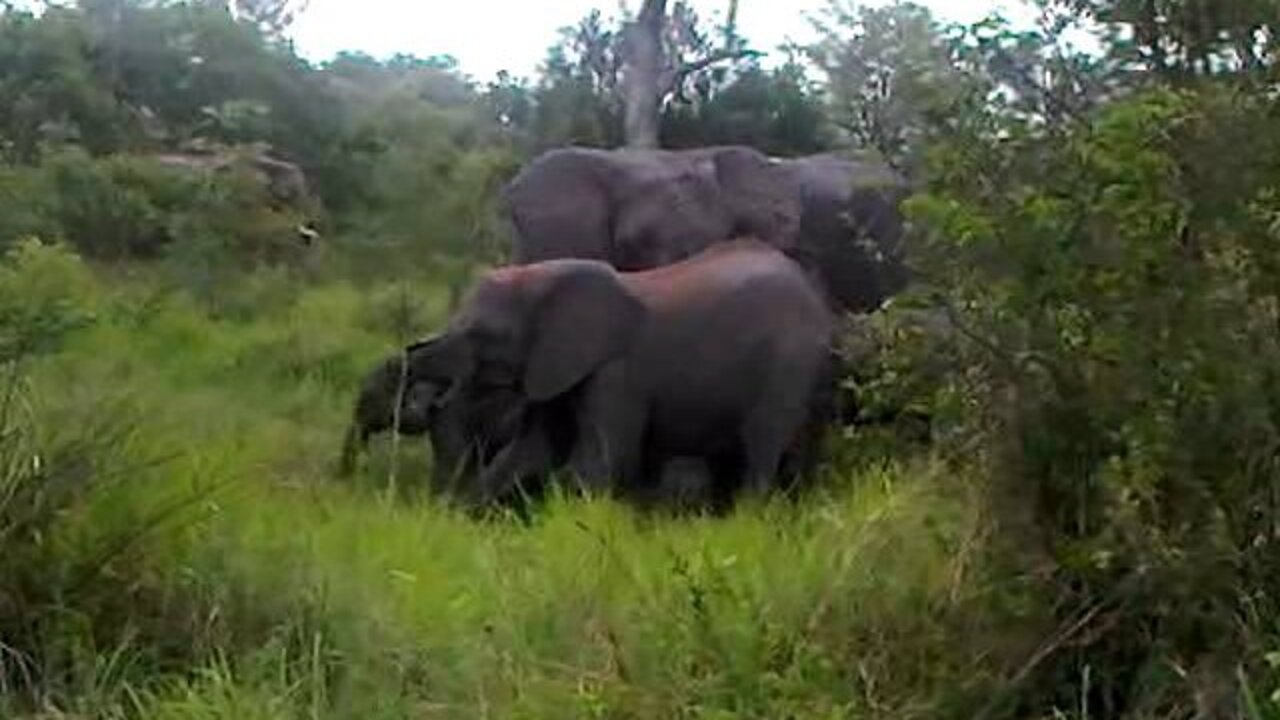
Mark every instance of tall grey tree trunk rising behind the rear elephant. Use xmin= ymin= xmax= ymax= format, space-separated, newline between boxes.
xmin=622 ymin=0 xmax=667 ymax=147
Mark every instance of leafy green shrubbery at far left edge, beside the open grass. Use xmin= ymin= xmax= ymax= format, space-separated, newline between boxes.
xmin=0 ymin=241 xmax=204 ymax=706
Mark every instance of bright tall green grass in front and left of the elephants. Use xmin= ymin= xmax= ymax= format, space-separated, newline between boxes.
xmin=0 ymin=244 xmax=1036 ymax=719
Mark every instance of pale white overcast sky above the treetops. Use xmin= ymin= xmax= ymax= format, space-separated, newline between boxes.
xmin=292 ymin=0 xmax=1033 ymax=81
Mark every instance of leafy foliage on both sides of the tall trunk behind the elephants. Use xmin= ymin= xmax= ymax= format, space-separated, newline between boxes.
xmin=486 ymin=3 xmax=828 ymax=155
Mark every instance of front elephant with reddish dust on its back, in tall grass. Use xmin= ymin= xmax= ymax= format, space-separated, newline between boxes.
xmin=406 ymin=238 xmax=833 ymax=507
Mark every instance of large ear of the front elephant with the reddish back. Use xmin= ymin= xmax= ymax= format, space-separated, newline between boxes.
xmin=524 ymin=263 xmax=646 ymax=402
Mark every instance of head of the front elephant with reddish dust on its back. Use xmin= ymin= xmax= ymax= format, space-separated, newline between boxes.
xmin=394 ymin=260 xmax=644 ymax=502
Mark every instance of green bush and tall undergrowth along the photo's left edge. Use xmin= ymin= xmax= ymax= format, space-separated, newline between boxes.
xmin=0 ymin=241 xmax=222 ymax=716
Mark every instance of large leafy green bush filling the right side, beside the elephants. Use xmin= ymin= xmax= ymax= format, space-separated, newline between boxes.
xmin=890 ymin=91 xmax=1280 ymax=716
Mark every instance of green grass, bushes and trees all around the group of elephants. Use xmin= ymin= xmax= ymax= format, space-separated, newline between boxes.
xmin=0 ymin=0 xmax=1280 ymax=720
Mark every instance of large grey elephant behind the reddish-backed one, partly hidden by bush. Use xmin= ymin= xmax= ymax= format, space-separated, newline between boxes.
xmin=503 ymin=146 xmax=906 ymax=313
